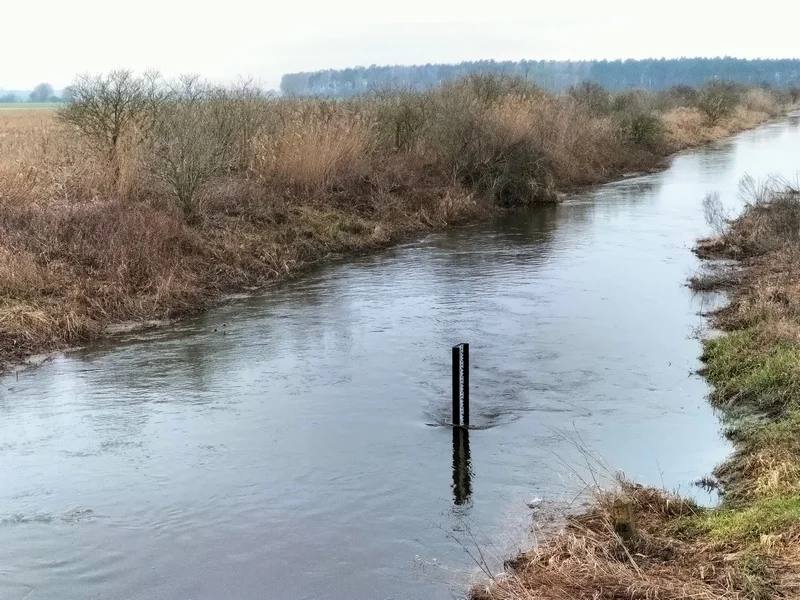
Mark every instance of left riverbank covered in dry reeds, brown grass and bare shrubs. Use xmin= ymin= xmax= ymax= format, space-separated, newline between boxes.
xmin=0 ymin=73 xmax=791 ymax=367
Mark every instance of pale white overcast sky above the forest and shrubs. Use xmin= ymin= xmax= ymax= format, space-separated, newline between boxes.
xmin=6 ymin=0 xmax=800 ymax=89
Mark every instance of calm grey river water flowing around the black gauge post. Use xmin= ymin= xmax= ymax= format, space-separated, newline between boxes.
xmin=0 ymin=117 xmax=800 ymax=600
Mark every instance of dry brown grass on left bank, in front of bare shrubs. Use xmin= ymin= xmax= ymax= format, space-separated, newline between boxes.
xmin=0 ymin=104 xmax=487 ymax=365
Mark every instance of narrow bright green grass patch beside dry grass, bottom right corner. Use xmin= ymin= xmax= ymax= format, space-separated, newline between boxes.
xmin=676 ymin=496 xmax=800 ymax=543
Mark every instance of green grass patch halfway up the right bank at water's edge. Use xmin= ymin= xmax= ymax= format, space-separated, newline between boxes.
xmin=703 ymin=326 xmax=800 ymax=414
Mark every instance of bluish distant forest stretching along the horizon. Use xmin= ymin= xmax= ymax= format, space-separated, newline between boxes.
xmin=281 ymin=57 xmax=800 ymax=97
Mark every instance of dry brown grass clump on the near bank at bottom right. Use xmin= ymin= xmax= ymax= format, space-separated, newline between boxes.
xmin=471 ymin=481 xmax=800 ymax=600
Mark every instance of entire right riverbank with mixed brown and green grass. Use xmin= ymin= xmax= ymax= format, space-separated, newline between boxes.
xmin=473 ymin=181 xmax=800 ymax=600
